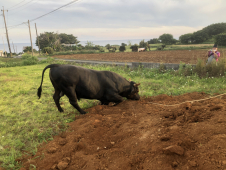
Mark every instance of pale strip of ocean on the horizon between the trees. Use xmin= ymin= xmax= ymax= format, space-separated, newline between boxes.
xmin=0 ymin=39 xmax=149 ymax=53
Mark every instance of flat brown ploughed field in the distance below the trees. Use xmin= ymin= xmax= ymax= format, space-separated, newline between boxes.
xmin=53 ymin=50 xmax=226 ymax=64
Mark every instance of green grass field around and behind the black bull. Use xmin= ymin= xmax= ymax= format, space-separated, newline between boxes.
xmin=0 ymin=60 xmax=226 ymax=169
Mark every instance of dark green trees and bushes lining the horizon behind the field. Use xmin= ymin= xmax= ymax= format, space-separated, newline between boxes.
xmin=24 ymin=23 xmax=226 ymax=54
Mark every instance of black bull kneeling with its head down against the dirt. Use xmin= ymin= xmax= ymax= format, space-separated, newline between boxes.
xmin=37 ymin=64 xmax=140 ymax=114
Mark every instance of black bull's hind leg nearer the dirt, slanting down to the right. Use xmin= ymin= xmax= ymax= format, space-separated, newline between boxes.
xmin=61 ymin=85 xmax=86 ymax=114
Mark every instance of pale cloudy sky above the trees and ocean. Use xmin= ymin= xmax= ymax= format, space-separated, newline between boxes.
xmin=0 ymin=0 xmax=226 ymax=43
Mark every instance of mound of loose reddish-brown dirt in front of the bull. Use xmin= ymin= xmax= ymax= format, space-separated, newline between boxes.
xmin=18 ymin=93 xmax=226 ymax=170
